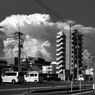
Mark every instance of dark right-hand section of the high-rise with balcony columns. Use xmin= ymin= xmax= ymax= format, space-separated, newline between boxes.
xmin=71 ymin=29 xmax=83 ymax=78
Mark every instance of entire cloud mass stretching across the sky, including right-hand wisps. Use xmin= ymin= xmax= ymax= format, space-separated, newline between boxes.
xmin=0 ymin=13 xmax=95 ymax=60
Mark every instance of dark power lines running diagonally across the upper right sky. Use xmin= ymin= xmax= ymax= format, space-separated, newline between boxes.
xmin=35 ymin=0 xmax=95 ymax=42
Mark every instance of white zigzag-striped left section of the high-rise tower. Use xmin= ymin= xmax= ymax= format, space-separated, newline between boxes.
xmin=56 ymin=31 xmax=66 ymax=80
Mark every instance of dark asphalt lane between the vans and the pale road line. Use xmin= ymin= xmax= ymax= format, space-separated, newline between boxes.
xmin=0 ymin=82 xmax=69 ymax=90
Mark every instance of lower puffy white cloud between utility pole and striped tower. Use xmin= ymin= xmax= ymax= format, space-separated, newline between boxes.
xmin=23 ymin=35 xmax=51 ymax=60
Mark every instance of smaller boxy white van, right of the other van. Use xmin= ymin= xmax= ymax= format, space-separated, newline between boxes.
xmin=24 ymin=71 xmax=43 ymax=83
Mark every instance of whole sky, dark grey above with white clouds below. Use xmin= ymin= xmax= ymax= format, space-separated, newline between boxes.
xmin=0 ymin=0 xmax=95 ymax=60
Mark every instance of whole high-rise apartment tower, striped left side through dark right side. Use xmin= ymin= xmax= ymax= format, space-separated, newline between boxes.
xmin=56 ymin=30 xmax=83 ymax=80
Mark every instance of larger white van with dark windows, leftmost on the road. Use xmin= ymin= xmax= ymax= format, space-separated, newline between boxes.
xmin=1 ymin=71 xmax=24 ymax=84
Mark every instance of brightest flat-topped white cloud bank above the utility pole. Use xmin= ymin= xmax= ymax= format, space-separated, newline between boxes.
xmin=0 ymin=14 xmax=53 ymax=34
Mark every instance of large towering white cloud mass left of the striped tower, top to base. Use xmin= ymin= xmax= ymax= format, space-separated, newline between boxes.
xmin=0 ymin=14 xmax=55 ymax=60
